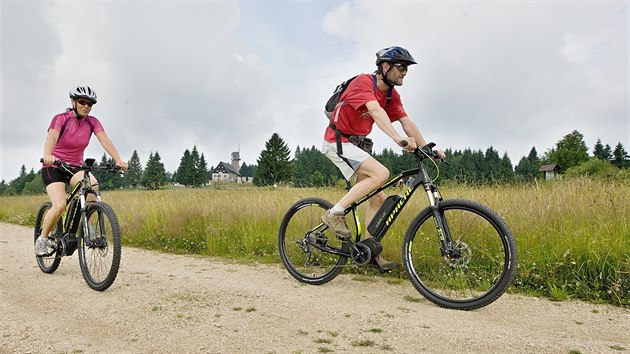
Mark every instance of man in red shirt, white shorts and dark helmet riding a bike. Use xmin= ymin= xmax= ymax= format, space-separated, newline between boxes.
xmin=322 ymin=47 xmax=444 ymax=272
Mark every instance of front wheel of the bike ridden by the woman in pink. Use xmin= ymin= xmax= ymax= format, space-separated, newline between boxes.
xmin=79 ymin=202 xmax=121 ymax=291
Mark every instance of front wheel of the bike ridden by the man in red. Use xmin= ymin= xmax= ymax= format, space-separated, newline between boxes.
xmin=403 ymin=199 xmax=517 ymax=310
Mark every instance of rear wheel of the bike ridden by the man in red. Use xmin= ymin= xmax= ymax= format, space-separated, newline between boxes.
xmin=278 ymin=198 xmax=350 ymax=285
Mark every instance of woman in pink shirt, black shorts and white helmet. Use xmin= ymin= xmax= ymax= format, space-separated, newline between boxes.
xmin=35 ymin=86 xmax=128 ymax=256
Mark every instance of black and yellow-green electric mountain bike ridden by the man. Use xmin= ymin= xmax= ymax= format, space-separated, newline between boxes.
xmin=278 ymin=143 xmax=517 ymax=310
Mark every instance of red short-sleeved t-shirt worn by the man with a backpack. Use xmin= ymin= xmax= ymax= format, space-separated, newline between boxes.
xmin=324 ymin=74 xmax=407 ymax=143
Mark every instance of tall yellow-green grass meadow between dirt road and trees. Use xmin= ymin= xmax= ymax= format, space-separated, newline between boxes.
xmin=0 ymin=177 xmax=630 ymax=307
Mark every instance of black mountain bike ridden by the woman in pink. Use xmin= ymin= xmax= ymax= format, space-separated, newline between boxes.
xmin=35 ymin=159 xmax=121 ymax=291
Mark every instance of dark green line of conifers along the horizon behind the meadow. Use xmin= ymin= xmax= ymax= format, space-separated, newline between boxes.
xmin=0 ymin=131 xmax=630 ymax=195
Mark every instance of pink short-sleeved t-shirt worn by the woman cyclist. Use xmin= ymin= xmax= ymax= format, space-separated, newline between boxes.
xmin=44 ymin=111 xmax=105 ymax=166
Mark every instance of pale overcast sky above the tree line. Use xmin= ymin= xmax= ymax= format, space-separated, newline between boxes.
xmin=0 ymin=0 xmax=630 ymax=182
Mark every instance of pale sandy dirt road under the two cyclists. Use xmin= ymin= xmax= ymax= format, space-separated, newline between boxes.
xmin=0 ymin=224 xmax=630 ymax=353
